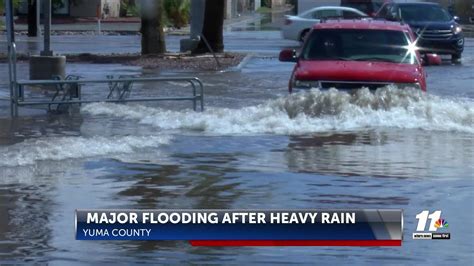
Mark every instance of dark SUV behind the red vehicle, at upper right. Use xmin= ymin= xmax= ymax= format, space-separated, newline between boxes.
xmin=376 ymin=2 xmax=464 ymax=61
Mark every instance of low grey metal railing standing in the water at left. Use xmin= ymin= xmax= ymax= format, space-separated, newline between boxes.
xmin=11 ymin=76 xmax=204 ymax=116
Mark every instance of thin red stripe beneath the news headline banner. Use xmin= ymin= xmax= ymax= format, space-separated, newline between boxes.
xmin=189 ymin=240 xmax=402 ymax=247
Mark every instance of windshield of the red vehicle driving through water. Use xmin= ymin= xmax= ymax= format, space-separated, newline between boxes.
xmin=301 ymin=29 xmax=417 ymax=64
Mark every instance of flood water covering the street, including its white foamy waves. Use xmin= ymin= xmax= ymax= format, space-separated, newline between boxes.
xmin=0 ymin=54 xmax=474 ymax=265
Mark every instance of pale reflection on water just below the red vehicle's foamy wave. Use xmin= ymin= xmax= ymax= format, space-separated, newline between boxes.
xmin=285 ymin=130 xmax=474 ymax=178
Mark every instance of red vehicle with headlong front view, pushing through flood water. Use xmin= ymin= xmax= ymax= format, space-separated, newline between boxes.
xmin=280 ymin=19 xmax=436 ymax=93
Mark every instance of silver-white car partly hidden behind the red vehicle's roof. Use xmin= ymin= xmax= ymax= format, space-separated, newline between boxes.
xmin=281 ymin=6 xmax=367 ymax=42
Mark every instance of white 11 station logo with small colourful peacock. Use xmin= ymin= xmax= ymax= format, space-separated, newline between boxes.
xmin=413 ymin=210 xmax=451 ymax=239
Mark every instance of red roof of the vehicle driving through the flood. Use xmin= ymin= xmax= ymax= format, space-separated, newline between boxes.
xmin=313 ymin=19 xmax=410 ymax=31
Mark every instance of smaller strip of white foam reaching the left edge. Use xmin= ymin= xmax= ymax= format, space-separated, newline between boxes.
xmin=0 ymin=136 xmax=170 ymax=167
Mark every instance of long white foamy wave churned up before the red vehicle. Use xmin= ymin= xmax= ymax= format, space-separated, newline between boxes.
xmin=82 ymin=87 xmax=474 ymax=135
